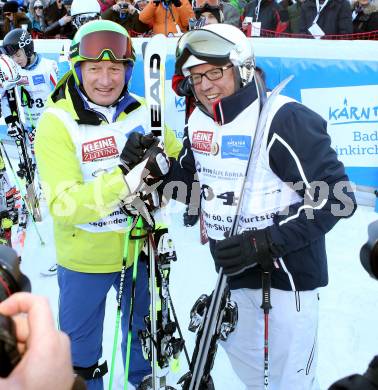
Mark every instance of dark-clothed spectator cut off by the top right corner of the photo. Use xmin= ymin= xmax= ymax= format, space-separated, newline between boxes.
xmin=352 ymin=0 xmax=378 ymax=33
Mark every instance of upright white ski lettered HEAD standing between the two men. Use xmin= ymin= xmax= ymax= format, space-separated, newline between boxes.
xmin=138 ymin=34 xmax=189 ymax=390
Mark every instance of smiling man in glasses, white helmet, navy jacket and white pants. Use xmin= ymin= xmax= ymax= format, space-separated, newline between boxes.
xmin=125 ymin=24 xmax=356 ymax=390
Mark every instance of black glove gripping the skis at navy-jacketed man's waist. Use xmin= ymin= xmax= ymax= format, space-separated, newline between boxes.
xmin=214 ymin=228 xmax=276 ymax=276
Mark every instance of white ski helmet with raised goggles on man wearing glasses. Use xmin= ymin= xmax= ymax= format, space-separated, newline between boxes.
xmin=176 ymin=24 xmax=255 ymax=86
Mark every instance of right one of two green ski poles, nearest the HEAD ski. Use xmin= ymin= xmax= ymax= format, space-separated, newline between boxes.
xmin=124 ymin=216 xmax=143 ymax=390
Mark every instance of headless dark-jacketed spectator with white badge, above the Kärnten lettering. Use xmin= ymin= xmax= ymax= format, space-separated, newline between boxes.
xmin=299 ymin=0 xmax=353 ymax=38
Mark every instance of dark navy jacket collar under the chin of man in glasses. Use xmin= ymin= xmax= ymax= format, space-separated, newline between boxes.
xmin=213 ymin=80 xmax=258 ymax=125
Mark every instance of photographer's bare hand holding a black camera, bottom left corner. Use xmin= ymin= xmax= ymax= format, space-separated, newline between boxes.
xmin=0 ymin=245 xmax=86 ymax=390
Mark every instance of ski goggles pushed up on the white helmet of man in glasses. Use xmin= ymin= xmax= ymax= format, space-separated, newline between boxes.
xmin=176 ymin=29 xmax=235 ymax=71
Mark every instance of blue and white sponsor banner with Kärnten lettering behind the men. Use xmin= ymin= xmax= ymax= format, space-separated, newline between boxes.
xmin=2 ymin=38 xmax=378 ymax=188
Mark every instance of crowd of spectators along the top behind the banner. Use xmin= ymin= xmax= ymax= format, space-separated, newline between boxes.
xmin=0 ymin=0 xmax=378 ymax=39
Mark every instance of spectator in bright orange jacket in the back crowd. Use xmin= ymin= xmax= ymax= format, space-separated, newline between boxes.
xmin=139 ymin=0 xmax=194 ymax=36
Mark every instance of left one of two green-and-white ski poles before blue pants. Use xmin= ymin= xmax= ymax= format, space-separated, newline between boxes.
xmin=108 ymin=217 xmax=132 ymax=390
